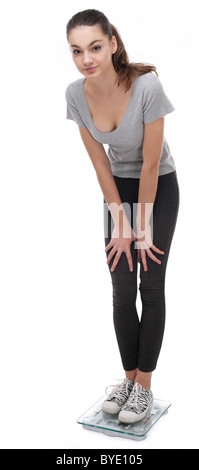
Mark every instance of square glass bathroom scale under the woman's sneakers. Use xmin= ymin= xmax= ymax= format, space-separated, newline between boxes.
xmin=77 ymin=382 xmax=171 ymax=440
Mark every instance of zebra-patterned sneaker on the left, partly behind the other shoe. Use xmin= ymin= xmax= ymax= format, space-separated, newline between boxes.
xmin=102 ymin=378 xmax=134 ymax=414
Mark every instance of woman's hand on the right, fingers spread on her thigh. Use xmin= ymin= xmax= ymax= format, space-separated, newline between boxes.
xmin=136 ymin=224 xmax=164 ymax=271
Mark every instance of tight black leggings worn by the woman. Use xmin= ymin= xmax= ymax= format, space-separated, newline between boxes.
xmin=104 ymin=171 xmax=179 ymax=372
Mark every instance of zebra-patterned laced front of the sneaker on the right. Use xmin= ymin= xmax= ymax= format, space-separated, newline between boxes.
xmin=123 ymin=383 xmax=149 ymax=412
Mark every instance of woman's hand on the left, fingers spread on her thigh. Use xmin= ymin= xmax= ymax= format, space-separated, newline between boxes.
xmin=105 ymin=225 xmax=136 ymax=272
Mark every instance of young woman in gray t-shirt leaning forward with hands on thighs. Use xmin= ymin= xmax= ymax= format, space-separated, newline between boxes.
xmin=65 ymin=9 xmax=179 ymax=423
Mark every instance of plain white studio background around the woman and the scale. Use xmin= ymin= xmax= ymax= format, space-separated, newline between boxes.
xmin=0 ymin=0 xmax=199 ymax=449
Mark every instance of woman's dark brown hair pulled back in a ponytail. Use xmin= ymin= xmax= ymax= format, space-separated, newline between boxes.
xmin=66 ymin=9 xmax=159 ymax=92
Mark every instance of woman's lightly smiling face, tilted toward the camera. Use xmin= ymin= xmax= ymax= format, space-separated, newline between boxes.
xmin=68 ymin=25 xmax=117 ymax=79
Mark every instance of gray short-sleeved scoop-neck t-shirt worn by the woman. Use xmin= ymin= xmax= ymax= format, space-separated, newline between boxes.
xmin=65 ymin=72 xmax=176 ymax=178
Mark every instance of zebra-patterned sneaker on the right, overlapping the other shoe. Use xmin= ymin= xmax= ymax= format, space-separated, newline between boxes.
xmin=118 ymin=383 xmax=153 ymax=424
